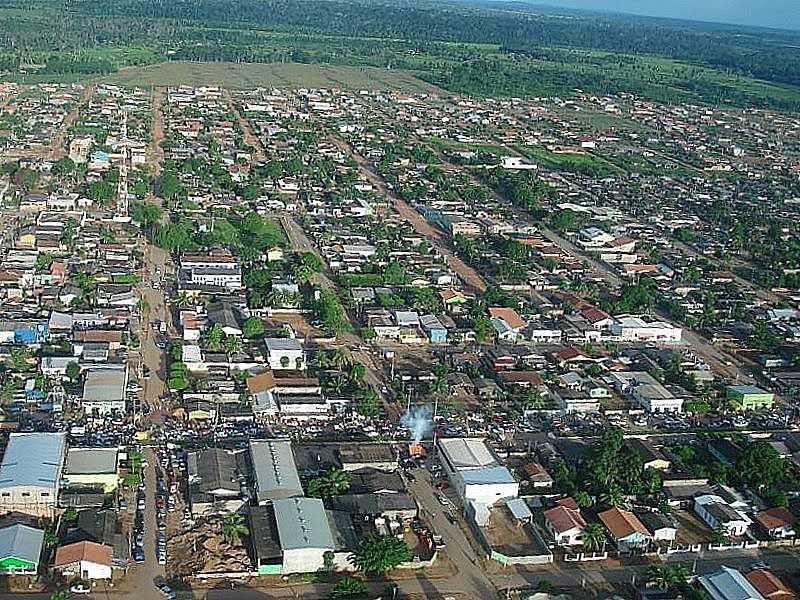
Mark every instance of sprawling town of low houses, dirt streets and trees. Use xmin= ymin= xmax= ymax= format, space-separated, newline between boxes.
xmin=0 ymin=83 xmax=800 ymax=600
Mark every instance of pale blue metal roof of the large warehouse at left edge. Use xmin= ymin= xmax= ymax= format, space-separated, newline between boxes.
xmin=0 ymin=433 xmax=67 ymax=489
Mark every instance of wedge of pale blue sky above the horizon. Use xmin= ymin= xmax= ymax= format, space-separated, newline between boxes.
xmin=532 ymin=0 xmax=800 ymax=29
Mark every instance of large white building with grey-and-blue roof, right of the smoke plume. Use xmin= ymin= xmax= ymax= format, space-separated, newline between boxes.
xmin=438 ymin=438 xmax=519 ymax=505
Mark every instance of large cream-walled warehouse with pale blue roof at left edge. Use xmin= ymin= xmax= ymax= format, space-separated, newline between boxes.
xmin=0 ymin=433 xmax=67 ymax=518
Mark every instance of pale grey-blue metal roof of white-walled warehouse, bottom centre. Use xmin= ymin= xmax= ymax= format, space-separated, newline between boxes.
xmin=272 ymin=498 xmax=334 ymax=552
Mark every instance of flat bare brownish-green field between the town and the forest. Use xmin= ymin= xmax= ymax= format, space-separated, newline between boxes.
xmin=102 ymin=62 xmax=443 ymax=94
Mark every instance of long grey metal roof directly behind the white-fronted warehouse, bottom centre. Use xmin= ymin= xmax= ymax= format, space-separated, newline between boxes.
xmin=250 ymin=440 xmax=303 ymax=502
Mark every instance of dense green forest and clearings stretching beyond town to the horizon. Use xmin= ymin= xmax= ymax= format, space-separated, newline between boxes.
xmin=0 ymin=0 xmax=800 ymax=109
